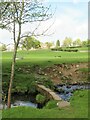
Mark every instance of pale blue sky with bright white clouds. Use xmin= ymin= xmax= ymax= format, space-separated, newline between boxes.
xmin=0 ymin=0 xmax=88 ymax=44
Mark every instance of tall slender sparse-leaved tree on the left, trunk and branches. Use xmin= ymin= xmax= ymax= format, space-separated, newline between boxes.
xmin=0 ymin=0 xmax=52 ymax=108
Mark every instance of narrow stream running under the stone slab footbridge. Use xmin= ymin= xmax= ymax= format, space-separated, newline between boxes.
xmin=1 ymin=84 xmax=90 ymax=108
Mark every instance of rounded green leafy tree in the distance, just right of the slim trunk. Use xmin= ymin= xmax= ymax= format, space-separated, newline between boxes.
xmin=21 ymin=36 xmax=40 ymax=50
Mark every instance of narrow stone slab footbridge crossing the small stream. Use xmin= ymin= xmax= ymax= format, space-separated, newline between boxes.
xmin=36 ymin=84 xmax=70 ymax=108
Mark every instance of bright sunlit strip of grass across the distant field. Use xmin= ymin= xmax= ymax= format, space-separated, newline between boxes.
xmin=2 ymin=50 xmax=88 ymax=65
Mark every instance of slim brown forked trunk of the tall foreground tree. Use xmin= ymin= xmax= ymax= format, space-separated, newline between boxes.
xmin=7 ymin=0 xmax=24 ymax=108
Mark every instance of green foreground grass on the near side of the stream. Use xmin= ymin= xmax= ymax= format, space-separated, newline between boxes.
xmin=2 ymin=90 xmax=90 ymax=118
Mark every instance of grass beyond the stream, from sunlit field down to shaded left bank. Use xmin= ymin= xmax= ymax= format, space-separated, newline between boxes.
xmin=2 ymin=50 xmax=88 ymax=93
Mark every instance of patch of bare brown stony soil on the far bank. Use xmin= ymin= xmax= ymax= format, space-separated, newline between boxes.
xmin=38 ymin=63 xmax=88 ymax=84
